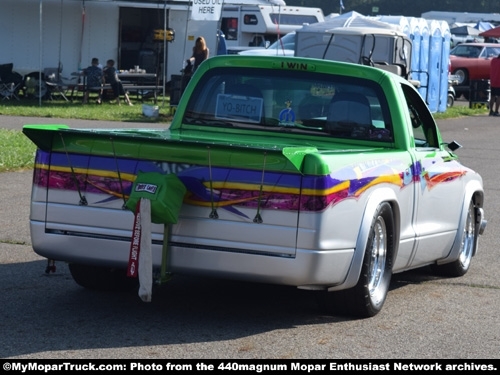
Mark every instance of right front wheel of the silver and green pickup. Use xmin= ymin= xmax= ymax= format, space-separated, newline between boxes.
xmin=432 ymin=202 xmax=477 ymax=277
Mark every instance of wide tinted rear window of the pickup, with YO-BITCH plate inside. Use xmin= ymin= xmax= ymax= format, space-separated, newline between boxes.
xmin=183 ymin=68 xmax=392 ymax=142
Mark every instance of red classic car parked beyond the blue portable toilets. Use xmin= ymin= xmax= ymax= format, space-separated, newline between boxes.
xmin=450 ymin=43 xmax=500 ymax=87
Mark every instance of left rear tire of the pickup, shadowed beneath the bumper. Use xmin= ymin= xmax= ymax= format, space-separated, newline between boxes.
xmin=69 ymin=263 xmax=139 ymax=291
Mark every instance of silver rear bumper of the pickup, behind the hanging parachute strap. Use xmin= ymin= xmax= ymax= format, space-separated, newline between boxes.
xmin=31 ymin=220 xmax=354 ymax=289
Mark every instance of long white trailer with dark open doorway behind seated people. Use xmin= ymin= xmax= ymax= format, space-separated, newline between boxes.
xmin=0 ymin=0 xmax=222 ymax=87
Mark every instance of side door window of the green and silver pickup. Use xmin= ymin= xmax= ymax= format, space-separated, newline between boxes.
xmin=402 ymin=84 xmax=439 ymax=148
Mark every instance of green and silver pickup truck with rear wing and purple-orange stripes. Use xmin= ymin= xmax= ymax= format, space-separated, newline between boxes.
xmin=23 ymin=56 xmax=486 ymax=317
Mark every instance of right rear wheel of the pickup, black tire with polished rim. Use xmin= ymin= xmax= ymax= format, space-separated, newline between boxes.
xmin=321 ymin=202 xmax=395 ymax=318
